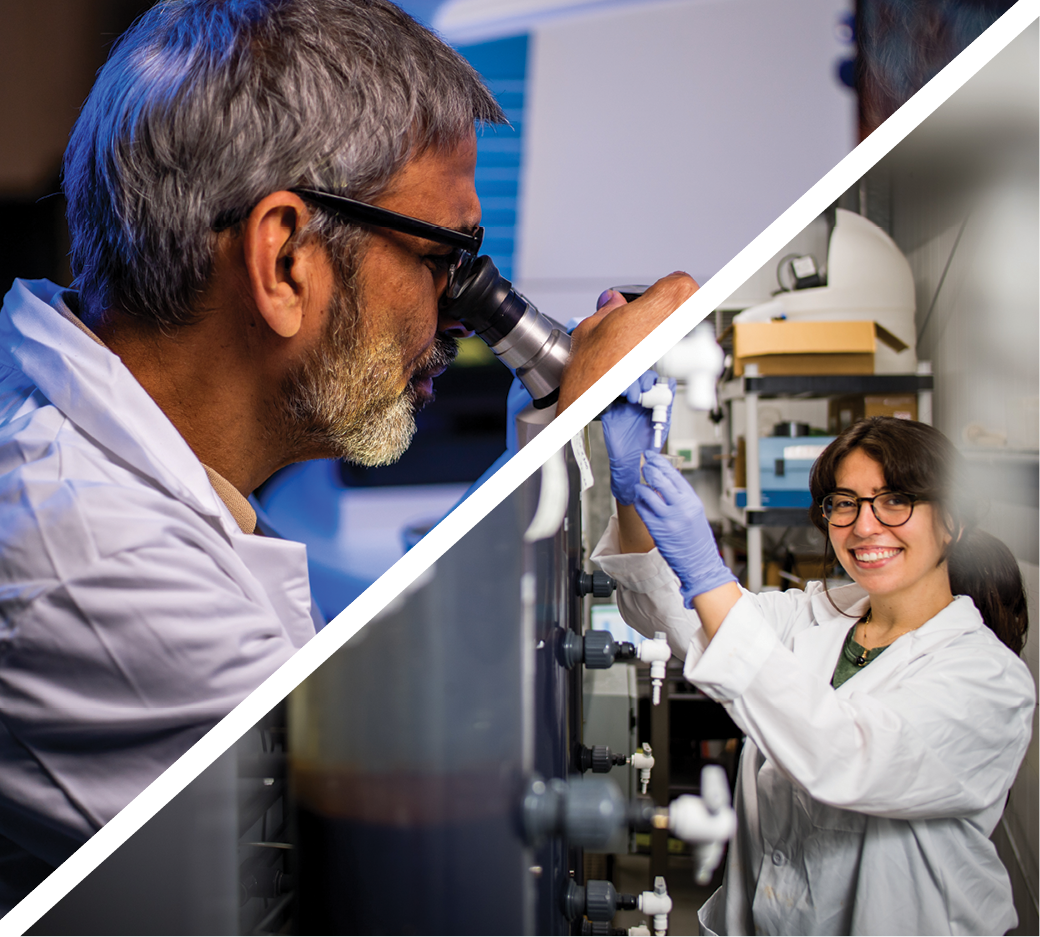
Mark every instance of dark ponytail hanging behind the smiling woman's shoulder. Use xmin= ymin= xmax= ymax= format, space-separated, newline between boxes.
xmin=946 ymin=528 xmax=1029 ymax=654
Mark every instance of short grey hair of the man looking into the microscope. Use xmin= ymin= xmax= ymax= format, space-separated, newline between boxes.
xmin=63 ymin=0 xmax=505 ymax=330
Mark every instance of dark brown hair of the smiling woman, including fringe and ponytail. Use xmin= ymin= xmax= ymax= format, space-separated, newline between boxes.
xmin=809 ymin=416 xmax=1029 ymax=654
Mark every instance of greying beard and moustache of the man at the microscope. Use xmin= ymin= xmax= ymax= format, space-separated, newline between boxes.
xmin=283 ymin=280 xmax=459 ymax=466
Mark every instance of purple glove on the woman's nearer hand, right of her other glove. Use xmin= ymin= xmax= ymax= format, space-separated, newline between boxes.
xmin=634 ymin=451 xmax=736 ymax=608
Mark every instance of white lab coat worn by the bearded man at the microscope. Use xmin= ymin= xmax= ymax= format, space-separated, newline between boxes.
xmin=0 ymin=281 xmax=315 ymax=912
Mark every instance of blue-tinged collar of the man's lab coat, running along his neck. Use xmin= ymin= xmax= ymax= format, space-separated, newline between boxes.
xmin=0 ymin=280 xmax=231 ymax=533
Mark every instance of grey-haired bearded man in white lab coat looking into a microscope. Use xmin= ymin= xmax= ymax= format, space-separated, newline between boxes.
xmin=0 ymin=0 xmax=696 ymax=910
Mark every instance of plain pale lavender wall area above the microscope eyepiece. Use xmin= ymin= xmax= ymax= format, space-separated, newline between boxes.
xmin=517 ymin=0 xmax=856 ymax=321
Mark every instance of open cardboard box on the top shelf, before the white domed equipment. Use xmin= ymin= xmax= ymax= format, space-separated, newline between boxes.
xmin=733 ymin=319 xmax=907 ymax=376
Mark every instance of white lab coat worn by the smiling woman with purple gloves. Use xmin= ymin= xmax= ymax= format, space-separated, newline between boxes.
xmin=592 ymin=519 xmax=1036 ymax=934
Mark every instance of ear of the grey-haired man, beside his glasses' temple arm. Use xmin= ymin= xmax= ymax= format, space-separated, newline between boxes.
xmin=242 ymin=191 xmax=320 ymax=338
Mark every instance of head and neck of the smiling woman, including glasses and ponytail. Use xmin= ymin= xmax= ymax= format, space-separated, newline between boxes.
xmin=809 ymin=417 xmax=1028 ymax=654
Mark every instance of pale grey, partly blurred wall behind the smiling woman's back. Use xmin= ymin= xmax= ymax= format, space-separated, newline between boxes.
xmin=881 ymin=23 xmax=1040 ymax=934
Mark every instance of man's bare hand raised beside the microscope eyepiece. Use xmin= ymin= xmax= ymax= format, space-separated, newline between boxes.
xmin=556 ymin=271 xmax=698 ymax=414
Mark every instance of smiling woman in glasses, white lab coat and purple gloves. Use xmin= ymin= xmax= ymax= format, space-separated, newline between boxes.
xmin=593 ymin=405 xmax=1035 ymax=934
